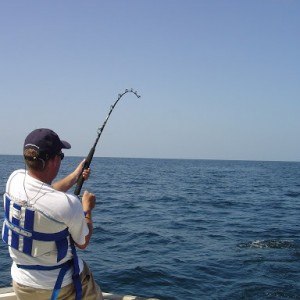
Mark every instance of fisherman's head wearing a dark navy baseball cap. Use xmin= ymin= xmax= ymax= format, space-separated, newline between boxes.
xmin=23 ymin=128 xmax=71 ymax=171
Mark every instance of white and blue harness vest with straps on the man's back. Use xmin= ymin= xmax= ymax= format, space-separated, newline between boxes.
xmin=2 ymin=193 xmax=82 ymax=300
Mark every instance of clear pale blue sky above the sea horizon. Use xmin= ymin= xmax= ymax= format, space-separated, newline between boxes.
xmin=0 ymin=0 xmax=300 ymax=161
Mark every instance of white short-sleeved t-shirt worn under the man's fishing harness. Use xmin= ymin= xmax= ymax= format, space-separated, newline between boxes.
xmin=6 ymin=170 xmax=89 ymax=289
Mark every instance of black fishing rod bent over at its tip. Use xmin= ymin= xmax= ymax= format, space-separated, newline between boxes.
xmin=74 ymin=89 xmax=141 ymax=196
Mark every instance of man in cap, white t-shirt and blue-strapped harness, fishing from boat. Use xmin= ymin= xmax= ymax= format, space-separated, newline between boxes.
xmin=2 ymin=128 xmax=103 ymax=300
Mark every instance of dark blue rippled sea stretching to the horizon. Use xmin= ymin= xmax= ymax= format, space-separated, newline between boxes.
xmin=0 ymin=156 xmax=300 ymax=300
